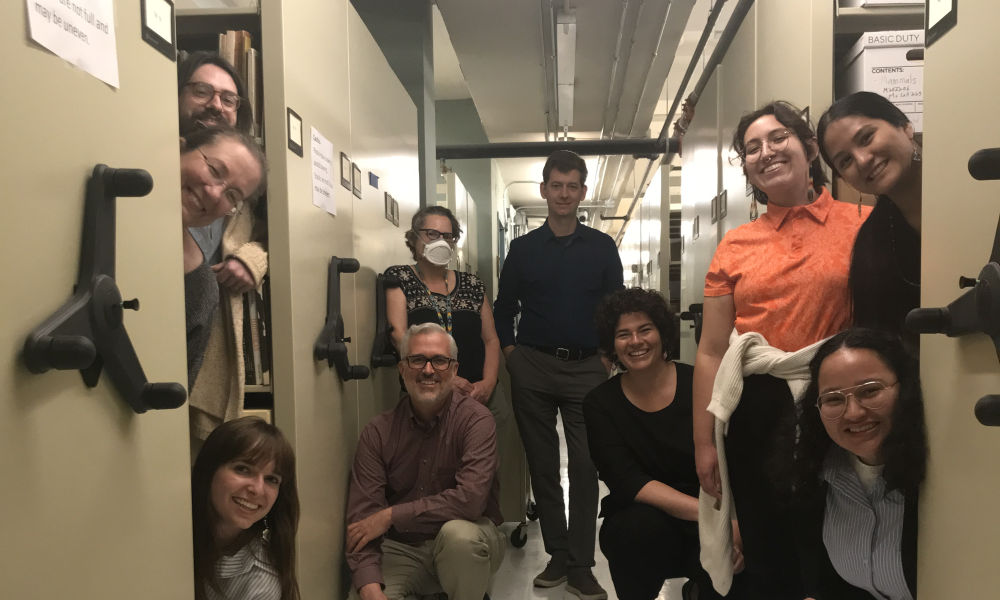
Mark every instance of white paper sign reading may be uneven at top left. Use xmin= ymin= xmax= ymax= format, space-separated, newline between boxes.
xmin=25 ymin=0 xmax=118 ymax=87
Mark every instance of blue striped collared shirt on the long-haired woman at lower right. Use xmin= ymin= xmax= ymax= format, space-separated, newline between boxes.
xmin=822 ymin=446 xmax=913 ymax=600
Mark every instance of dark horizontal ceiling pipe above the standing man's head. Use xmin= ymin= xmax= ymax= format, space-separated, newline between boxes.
xmin=437 ymin=138 xmax=677 ymax=160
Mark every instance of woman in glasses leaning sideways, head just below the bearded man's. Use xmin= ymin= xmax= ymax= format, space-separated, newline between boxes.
xmin=181 ymin=127 xmax=267 ymax=390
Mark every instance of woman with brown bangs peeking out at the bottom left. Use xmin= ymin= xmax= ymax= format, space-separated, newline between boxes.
xmin=191 ymin=417 xmax=299 ymax=600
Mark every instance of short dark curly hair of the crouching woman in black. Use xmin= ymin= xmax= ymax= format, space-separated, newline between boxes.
xmin=594 ymin=288 xmax=677 ymax=361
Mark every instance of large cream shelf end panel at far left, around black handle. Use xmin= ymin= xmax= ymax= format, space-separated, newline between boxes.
xmin=0 ymin=0 xmax=194 ymax=600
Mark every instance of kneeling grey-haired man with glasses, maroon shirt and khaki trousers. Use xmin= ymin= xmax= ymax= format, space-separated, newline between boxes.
xmin=346 ymin=323 xmax=504 ymax=600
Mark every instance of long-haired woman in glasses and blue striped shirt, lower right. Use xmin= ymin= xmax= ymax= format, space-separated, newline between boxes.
xmin=774 ymin=329 xmax=927 ymax=600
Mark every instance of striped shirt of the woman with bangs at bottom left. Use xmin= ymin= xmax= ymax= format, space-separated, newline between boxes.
xmin=205 ymin=537 xmax=281 ymax=600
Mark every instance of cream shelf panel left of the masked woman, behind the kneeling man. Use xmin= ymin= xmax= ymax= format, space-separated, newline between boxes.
xmin=348 ymin=6 xmax=420 ymax=432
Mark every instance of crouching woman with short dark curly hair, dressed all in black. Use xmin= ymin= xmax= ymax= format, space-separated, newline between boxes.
xmin=583 ymin=288 xmax=746 ymax=600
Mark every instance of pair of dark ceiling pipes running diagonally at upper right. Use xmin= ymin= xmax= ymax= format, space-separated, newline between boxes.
xmin=615 ymin=0 xmax=754 ymax=244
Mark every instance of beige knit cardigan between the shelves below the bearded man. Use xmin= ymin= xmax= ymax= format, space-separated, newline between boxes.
xmin=189 ymin=204 xmax=267 ymax=440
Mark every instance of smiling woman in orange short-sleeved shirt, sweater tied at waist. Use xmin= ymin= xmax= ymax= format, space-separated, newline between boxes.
xmin=694 ymin=102 xmax=870 ymax=600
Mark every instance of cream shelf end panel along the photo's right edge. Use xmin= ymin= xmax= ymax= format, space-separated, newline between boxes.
xmin=918 ymin=0 xmax=1000 ymax=600
